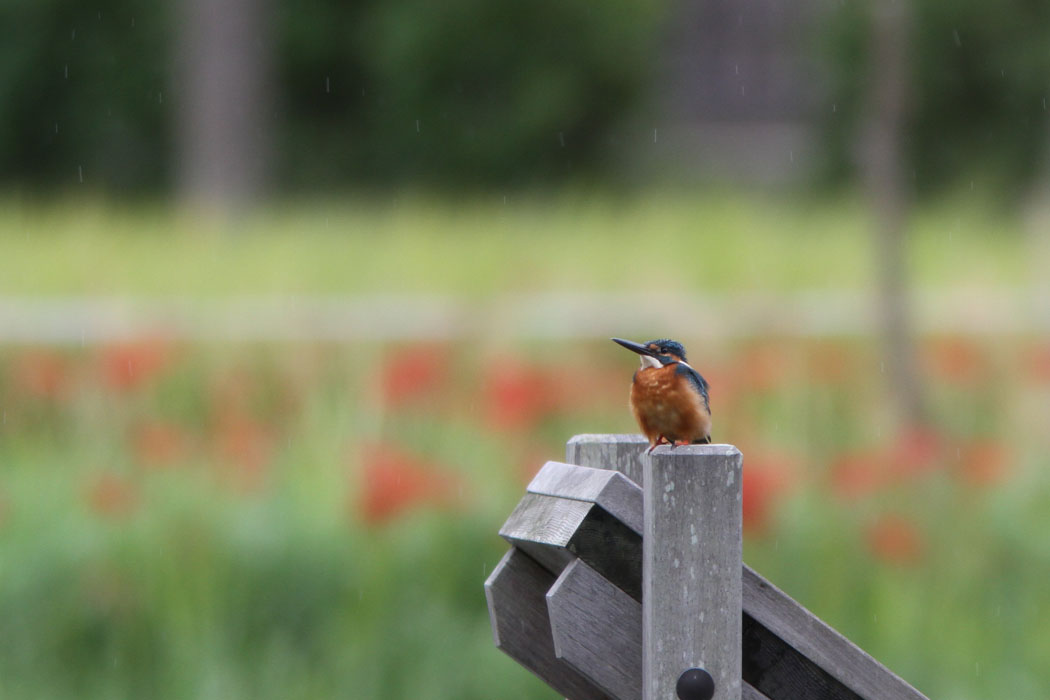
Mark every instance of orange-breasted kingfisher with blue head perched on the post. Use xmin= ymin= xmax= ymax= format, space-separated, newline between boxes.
xmin=612 ymin=338 xmax=711 ymax=454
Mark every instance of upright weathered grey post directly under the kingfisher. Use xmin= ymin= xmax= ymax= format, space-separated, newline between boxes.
xmin=642 ymin=445 xmax=742 ymax=700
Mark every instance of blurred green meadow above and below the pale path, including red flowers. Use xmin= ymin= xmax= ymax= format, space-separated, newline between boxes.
xmin=0 ymin=192 xmax=1050 ymax=700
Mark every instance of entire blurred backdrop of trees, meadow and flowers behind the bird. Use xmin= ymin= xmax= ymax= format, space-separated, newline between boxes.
xmin=0 ymin=0 xmax=1050 ymax=700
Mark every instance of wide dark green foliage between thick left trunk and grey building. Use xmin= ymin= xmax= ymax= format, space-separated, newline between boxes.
xmin=281 ymin=0 xmax=660 ymax=186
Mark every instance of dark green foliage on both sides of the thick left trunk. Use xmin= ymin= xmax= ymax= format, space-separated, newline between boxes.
xmin=0 ymin=0 xmax=663 ymax=192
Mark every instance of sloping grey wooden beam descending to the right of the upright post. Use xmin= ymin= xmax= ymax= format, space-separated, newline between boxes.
xmin=742 ymin=567 xmax=926 ymax=700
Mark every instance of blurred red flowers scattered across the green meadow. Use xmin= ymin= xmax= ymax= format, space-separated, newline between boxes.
xmin=4 ymin=338 xmax=1033 ymax=545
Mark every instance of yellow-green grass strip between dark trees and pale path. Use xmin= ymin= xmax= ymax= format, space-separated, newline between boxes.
xmin=0 ymin=191 xmax=1030 ymax=297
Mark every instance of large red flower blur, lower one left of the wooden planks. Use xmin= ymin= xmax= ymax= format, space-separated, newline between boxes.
xmin=357 ymin=444 xmax=463 ymax=524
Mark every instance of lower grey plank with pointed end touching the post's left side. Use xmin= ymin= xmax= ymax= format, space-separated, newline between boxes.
xmin=547 ymin=559 xmax=642 ymax=700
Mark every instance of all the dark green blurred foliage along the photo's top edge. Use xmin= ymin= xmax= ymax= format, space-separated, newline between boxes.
xmin=0 ymin=0 xmax=1050 ymax=192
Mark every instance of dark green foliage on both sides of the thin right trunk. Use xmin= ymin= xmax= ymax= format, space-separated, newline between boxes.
xmin=823 ymin=0 xmax=1050 ymax=196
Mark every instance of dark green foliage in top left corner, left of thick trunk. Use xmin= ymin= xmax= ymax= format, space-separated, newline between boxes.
xmin=0 ymin=0 xmax=170 ymax=192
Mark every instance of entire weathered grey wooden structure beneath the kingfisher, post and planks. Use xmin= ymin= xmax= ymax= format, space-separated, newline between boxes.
xmin=485 ymin=434 xmax=925 ymax=700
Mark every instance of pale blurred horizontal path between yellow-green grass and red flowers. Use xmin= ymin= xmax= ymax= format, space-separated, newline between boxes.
xmin=0 ymin=289 xmax=1037 ymax=343
